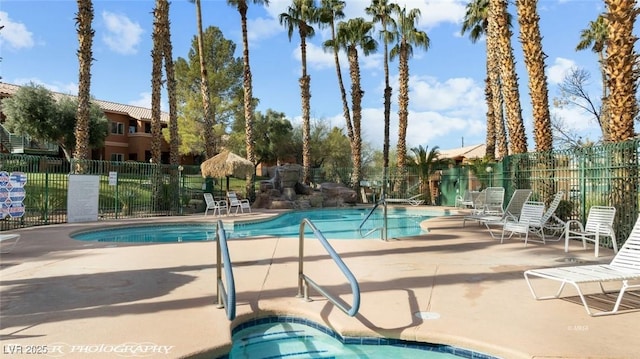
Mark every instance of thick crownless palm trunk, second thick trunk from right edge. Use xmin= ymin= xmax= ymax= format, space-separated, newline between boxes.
xmin=516 ymin=0 xmax=553 ymax=152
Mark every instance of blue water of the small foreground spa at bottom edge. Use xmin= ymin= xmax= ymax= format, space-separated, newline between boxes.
xmin=221 ymin=317 xmax=495 ymax=359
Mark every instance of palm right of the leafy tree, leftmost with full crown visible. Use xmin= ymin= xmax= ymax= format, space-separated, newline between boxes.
xmin=279 ymin=0 xmax=319 ymax=184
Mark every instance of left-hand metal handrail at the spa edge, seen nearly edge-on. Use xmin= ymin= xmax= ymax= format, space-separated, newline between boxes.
xmin=216 ymin=220 xmax=236 ymax=320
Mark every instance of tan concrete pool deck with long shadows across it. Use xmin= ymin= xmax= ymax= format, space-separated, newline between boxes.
xmin=0 ymin=207 xmax=640 ymax=358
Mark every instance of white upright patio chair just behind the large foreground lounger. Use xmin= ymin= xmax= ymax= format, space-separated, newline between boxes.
xmin=564 ymin=206 xmax=618 ymax=257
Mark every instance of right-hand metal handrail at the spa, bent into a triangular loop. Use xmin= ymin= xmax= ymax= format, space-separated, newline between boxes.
xmin=296 ymin=218 xmax=360 ymax=317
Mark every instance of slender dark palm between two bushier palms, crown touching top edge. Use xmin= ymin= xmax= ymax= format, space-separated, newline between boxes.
xmin=365 ymin=0 xmax=398 ymax=172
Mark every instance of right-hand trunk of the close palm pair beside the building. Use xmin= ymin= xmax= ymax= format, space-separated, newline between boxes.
xmin=157 ymin=0 xmax=180 ymax=166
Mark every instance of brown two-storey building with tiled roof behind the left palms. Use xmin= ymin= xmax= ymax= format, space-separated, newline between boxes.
xmin=0 ymin=82 xmax=193 ymax=164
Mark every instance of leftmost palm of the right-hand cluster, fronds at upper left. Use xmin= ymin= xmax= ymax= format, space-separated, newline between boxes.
xmin=461 ymin=0 xmax=504 ymax=160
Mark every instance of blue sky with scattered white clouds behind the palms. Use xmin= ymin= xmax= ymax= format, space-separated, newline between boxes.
xmin=0 ymin=0 xmax=638 ymax=150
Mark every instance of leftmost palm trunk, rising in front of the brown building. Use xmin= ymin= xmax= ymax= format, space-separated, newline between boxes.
xmin=74 ymin=0 xmax=95 ymax=172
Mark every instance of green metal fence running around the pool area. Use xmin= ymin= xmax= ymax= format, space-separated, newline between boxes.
xmin=0 ymin=140 xmax=640 ymax=250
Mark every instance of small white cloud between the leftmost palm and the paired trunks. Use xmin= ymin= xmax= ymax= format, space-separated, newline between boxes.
xmin=102 ymin=11 xmax=144 ymax=55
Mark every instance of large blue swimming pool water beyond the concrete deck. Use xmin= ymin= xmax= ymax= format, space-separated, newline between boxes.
xmin=72 ymin=208 xmax=444 ymax=243
